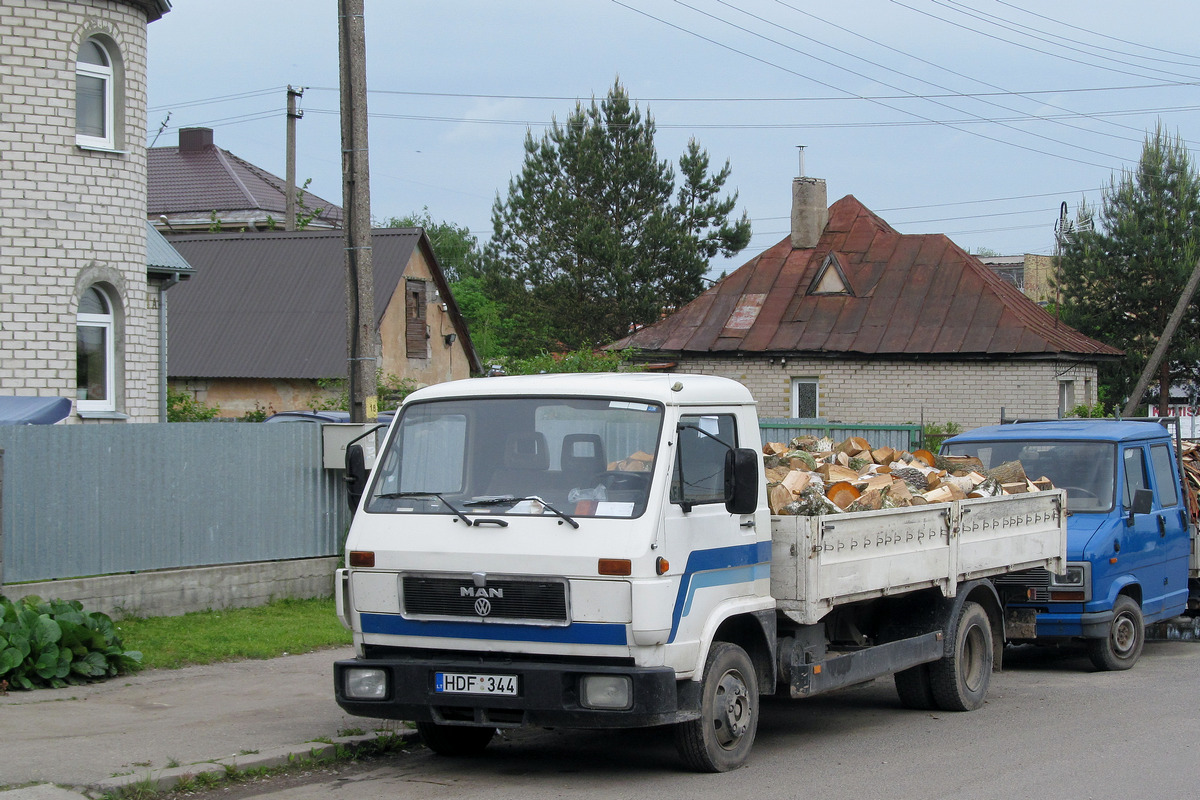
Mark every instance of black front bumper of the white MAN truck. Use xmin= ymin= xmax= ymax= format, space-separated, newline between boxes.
xmin=334 ymin=654 xmax=700 ymax=728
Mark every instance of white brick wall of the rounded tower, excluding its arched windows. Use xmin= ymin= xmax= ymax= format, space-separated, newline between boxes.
xmin=0 ymin=0 xmax=158 ymax=421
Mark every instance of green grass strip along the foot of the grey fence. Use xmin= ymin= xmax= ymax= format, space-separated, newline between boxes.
xmin=116 ymin=599 xmax=350 ymax=669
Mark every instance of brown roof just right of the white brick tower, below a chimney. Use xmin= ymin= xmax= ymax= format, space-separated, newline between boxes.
xmin=146 ymin=144 xmax=342 ymax=227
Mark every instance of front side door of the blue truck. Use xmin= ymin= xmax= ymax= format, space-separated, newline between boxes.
xmin=1114 ymin=445 xmax=1166 ymax=618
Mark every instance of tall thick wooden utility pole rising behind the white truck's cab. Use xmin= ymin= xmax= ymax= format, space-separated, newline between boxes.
xmin=337 ymin=0 xmax=379 ymax=422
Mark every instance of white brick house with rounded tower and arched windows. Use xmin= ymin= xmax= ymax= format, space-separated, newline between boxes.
xmin=0 ymin=0 xmax=178 ymax=422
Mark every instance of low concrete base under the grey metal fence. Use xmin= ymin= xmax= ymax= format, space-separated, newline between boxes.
xmin=0 ymin=557 xmax=340 ymax=619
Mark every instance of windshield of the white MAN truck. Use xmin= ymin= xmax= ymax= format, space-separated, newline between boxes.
xmin=366 ymin=397 xmax=664 ymax=519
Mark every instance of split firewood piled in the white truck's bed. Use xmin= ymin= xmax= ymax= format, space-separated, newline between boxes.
xmin=762 ymin=437 xmax=1056 ymax=517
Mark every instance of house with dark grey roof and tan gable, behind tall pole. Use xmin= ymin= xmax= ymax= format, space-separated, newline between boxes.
xmin=169 ymin=228 xmax=481 ymax=416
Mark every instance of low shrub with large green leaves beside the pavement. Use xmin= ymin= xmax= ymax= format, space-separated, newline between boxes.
xmin=0 ymin=596 xmax=142 ymax=688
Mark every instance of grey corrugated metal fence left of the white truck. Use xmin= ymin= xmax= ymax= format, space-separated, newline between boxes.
xmin=0 ymin=423 xmax=349 ymax=583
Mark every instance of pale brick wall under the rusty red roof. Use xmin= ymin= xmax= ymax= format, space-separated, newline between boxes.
xmin=677 ymin=356 xmax=1096 ymax=429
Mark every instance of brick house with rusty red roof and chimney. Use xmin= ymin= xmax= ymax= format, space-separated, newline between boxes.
xmin=612 ymin=178 xmax=1122 ymax=428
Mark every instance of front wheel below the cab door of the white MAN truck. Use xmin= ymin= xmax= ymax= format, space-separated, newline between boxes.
xmin=674 ymin=642 xmax=758 ymax=772
